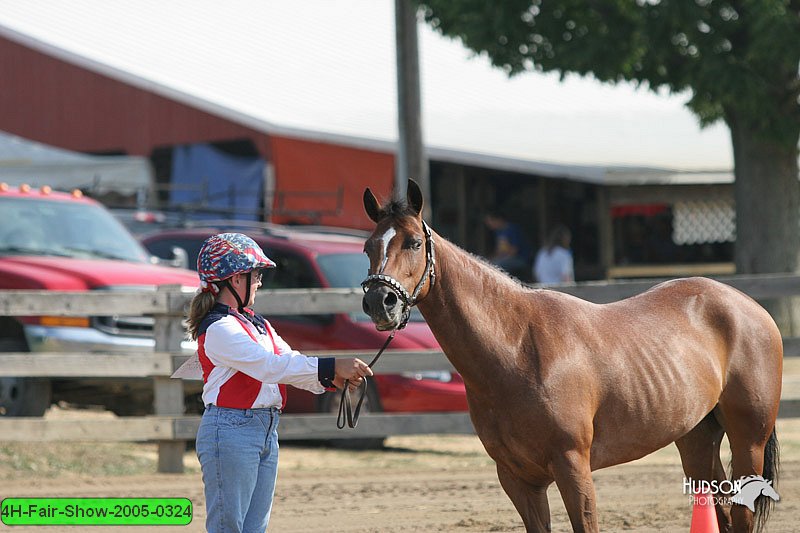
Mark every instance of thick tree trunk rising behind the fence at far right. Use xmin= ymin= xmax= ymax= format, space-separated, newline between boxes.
xmin=728 ymin=120 xmax=800 ymax=336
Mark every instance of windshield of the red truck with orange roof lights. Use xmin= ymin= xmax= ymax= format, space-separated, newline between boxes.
xmin=0 ymin=198 xmax=148 ymax=262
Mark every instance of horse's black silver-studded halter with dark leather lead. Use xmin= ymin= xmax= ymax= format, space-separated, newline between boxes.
xmin=336 ymin=220 xmax=436 ymax=429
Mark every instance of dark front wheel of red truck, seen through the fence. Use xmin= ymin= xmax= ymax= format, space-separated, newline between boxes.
xmin=0 ymin=338 xmax=52 ymax=416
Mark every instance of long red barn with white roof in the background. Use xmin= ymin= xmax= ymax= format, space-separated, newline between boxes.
xmin=0 ymin=0 xmax=732 ymax=279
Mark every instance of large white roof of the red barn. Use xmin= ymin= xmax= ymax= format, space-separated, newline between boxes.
xmin=0 ymin=0 xmax=732 ymax=183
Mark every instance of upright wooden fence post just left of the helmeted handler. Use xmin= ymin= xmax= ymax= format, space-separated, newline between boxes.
xmin=153 ymin=285 xmax=186 ymax=474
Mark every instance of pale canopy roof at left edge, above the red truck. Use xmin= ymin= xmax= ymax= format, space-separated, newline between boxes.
xmin=0 ymin=131 xmax=153 ymax=194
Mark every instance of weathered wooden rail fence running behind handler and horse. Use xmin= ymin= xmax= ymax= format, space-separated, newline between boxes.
xmin=0 ymin=275 xmax=800 ymax=472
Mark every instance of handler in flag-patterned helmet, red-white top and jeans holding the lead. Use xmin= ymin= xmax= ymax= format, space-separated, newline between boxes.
xmin=187 ymin=233 xmax=372 ymax=533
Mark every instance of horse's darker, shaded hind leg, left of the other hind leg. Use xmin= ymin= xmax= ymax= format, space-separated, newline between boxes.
xmin=675 ymin=413 xmax=733 ymax=533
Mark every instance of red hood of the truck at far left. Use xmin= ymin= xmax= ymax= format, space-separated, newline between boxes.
xmin=0 ymin=256 xmax=198 ymax=291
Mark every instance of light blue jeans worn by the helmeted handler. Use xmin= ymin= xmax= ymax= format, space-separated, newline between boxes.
xmin=197 ymin=405 xmax=280 ymax=533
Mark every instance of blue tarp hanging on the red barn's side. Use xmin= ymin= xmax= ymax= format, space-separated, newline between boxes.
xmin=170 ymin=144 xmax=265 ymax=220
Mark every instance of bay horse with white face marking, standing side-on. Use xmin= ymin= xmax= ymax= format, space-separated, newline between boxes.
xmin=362 ymin=180 xmax=783 ymax=532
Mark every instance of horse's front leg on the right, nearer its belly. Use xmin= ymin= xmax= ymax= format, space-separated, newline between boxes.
xmin=553 ymin=449 xmax=600 ymax=532
